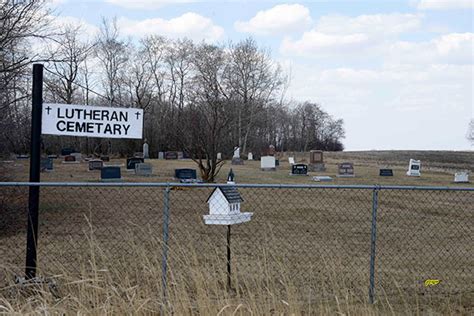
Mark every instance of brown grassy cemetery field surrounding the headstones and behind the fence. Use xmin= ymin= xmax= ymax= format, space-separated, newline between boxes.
xmin=0 ymin=152 xmax=474 ymax=315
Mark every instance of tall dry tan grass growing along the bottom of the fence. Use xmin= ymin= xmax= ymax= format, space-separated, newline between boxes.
xmin=0 ymin=220 xmax=472 ymax=315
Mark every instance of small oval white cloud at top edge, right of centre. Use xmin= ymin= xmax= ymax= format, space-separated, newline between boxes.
xmin=234 ymin=4 xmax=311 ymax=35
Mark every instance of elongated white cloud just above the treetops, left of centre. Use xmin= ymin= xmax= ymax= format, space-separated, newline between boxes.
xmin=117 ymin=12 xmax=224 ymax=41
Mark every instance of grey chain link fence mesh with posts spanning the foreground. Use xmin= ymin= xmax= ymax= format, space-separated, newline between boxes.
xmin=0 ymin=183 xmax=474 ymax=302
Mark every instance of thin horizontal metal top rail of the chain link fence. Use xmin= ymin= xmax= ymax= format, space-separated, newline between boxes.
xmin=0 ymin=182 xmax=474 ymax=192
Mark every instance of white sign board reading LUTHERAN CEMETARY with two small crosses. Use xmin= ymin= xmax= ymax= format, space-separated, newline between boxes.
xmin=41 ymin=103 xmax=143 ymax=139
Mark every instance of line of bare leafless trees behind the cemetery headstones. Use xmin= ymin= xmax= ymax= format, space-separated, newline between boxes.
xmin=0 ymin=1 xmax=344 ymax=180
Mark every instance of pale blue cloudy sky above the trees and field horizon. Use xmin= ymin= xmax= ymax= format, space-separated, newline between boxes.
xmin=47 ymin=0 xmax=474 ymax=150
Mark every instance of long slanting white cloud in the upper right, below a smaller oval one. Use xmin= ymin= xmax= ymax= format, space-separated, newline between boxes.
xmin=280 ymin=14 xmax=423 ymax=57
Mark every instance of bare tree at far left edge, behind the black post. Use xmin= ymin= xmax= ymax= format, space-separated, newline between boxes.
xmin=0 ymin=0 xmax=50 ymax=153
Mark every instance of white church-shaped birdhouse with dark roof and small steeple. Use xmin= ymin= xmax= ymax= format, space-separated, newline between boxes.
xmin=203 ymin=169 xmax=253 ymax=225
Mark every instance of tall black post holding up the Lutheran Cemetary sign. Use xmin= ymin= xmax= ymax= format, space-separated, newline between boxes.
xmin=25 ymin=64 xmax=43 ymax=279
